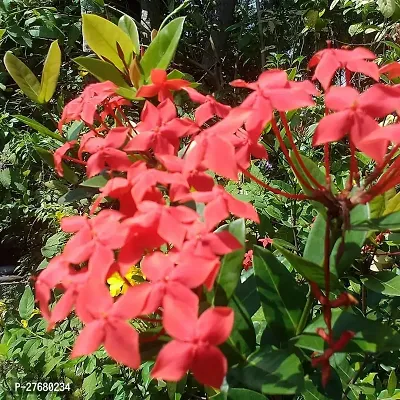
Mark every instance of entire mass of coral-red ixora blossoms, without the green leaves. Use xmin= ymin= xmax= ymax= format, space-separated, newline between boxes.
xmin=36 ymin=49 xmax=400 ymax=387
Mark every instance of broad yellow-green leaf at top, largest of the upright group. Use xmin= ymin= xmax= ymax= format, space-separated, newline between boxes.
xmin=82 ymin=14 xmax=134 ymax=71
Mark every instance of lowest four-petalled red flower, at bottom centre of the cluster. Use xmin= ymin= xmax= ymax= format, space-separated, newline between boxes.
xmin=151 ymin=300 xmax=234 ymax=388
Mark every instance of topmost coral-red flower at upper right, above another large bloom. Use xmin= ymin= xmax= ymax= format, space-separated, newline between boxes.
xmin=308 ymin=47 xmax=379 ymax=90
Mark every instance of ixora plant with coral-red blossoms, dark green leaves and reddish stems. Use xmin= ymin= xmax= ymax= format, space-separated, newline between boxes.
xmin=30 ymin=42 xmax=400 ymax=398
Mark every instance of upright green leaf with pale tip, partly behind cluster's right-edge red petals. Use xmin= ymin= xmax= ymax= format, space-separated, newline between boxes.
xmin=211 ymin=219 xmax=246 ymax=305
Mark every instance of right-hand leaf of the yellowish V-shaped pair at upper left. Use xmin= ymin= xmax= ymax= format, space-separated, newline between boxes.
xmin=38 ymin=40 xmax=61 ymax=103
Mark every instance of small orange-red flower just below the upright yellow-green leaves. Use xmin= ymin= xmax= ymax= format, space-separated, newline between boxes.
xmin=136 ymin=69 xmax=190 ymax=102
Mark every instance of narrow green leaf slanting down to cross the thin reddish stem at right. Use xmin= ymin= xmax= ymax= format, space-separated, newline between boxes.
xmin=273 ymin=243 xmax=340 ymax=288
